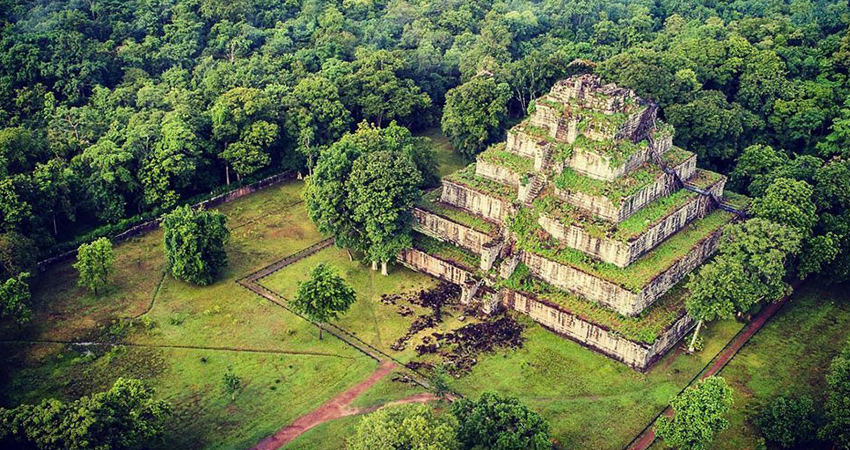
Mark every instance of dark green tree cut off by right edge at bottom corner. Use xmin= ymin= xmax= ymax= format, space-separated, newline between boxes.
xmin=818 ymin=341 xmax=850 ymax=450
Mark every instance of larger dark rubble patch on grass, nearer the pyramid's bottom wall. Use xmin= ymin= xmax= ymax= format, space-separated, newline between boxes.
xmin=416 ymin=315 xmax=524 ymax=376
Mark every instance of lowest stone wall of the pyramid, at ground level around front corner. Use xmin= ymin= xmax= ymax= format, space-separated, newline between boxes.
xmin=501 ymin=289 xmax=693 ymax=371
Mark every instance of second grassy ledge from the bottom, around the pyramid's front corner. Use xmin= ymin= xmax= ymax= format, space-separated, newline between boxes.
xmin=511 ymin=209 xmax=734 ymax=292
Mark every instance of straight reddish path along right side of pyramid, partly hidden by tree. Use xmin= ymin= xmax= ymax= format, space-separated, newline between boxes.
xmin=626 ymin=281 xmax=803 ymax=450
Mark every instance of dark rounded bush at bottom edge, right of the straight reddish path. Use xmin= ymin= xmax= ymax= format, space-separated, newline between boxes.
xmin=756 ymin=395 xmax=817 ymax=448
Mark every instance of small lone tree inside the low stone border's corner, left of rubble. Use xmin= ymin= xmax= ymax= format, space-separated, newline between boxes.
xmin=290 ymin=263 xmax=357 ymax=340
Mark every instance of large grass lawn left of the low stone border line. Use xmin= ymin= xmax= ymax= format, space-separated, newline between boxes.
xmin=0 ymin=182 xmax=376 ymax=449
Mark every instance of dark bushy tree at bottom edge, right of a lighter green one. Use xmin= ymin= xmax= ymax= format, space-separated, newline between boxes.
xmin=452 ymin=392 xmax=552 ymax=450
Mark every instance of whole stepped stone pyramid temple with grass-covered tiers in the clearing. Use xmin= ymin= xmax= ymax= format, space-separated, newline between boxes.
xmin=399 ymin=75 xmax=746 ymax=370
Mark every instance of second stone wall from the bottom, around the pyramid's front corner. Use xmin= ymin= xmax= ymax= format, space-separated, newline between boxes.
xmin=520 ymin=230 xmax=720 ymax=316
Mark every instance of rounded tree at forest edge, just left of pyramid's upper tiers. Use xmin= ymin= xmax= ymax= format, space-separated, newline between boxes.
xmin=442 ymin=76 xmax=511 ymax=159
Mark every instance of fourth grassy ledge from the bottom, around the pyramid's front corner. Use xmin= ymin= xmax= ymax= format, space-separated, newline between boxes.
xmin=555 ymin=164 xmax=664 ymax=206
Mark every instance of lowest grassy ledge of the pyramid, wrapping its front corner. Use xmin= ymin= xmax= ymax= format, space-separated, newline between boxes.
xmin=501 ymin=263 xmax=687 ymax=344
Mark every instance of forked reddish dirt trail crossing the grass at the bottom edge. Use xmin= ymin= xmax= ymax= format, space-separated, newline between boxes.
xmin=250 ymin=361 xmax=436 ymax=450
